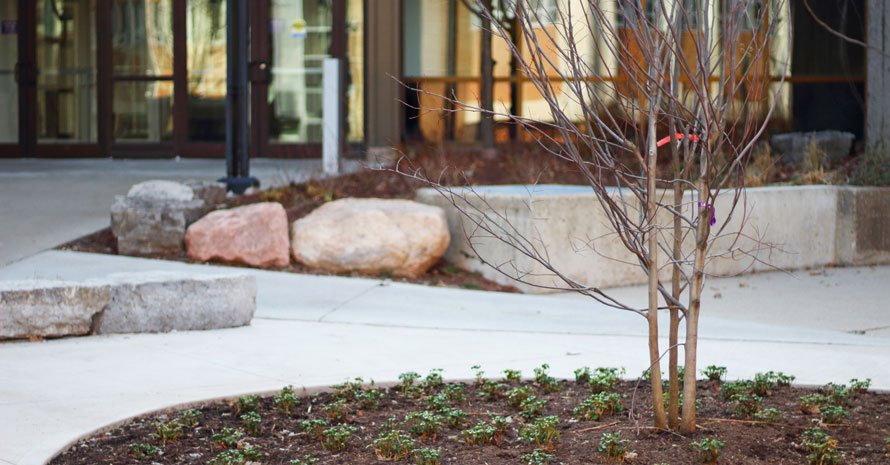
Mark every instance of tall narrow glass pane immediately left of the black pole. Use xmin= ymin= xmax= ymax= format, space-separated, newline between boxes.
xmin=186 ymin=0 xmax=226 ymax=142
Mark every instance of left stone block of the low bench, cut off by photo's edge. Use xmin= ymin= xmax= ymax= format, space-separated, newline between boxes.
xmin=0 ymin=280 xmax=111 ymax=338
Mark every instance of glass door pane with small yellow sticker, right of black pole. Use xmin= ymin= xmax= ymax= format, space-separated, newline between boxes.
xmin=269 ymin=0 xmax=331 ymax=143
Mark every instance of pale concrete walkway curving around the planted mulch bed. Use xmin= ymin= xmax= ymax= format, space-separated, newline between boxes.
xmin=0 ymin=251 xmax=890 ymax=465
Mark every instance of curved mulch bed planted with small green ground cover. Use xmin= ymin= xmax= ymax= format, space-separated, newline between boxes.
xmin=50 ymin=367 xmax=890 ymax=465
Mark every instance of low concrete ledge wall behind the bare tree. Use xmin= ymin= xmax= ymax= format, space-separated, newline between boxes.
xmin=416 ymin=185 xmax=890 ymax=293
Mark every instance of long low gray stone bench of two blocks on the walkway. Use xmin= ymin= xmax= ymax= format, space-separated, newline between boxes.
xmin=0 ymin=272 xmax=257 ymax=339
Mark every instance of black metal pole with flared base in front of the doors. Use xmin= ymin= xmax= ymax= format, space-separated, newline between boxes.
xmin=219 ymin=0 xmax=260 ymax=194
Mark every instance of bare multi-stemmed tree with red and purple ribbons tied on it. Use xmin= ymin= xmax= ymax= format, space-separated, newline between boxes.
xmin=396 ymin=0 xmax=790 ymax=433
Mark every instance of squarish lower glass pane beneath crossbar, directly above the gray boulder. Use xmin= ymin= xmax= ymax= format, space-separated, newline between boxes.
xmin=113 ymin=81 xmax=173 ymax=142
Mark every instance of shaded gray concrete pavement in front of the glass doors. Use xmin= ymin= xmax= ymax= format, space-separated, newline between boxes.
xmin=0 ymin=158 xmax=361 ymax=266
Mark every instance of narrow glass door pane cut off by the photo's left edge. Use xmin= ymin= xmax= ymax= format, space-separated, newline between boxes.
xmin=0 ymin=0 xmax=19 ymax=144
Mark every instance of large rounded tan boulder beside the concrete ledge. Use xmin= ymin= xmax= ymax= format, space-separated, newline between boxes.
xmin=291 ymin=199 xmax=451 ymax=277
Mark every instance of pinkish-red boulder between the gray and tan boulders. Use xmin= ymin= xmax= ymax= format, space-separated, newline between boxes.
xmin=185 ymin=202 xmax=290 ymax=267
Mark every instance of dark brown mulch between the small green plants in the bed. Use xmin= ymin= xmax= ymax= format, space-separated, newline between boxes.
xmin=50 ymin=374 xmax=890 ymax=465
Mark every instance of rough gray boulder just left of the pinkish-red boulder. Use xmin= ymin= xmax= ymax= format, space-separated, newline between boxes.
xmin=111 ymin=180 xmax=206 ymax=255
